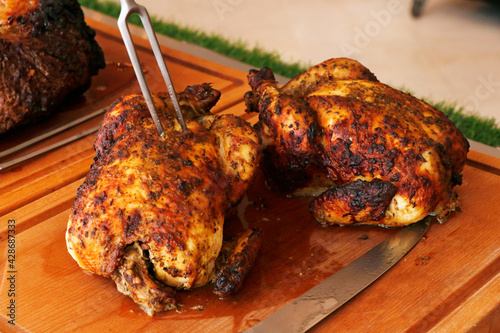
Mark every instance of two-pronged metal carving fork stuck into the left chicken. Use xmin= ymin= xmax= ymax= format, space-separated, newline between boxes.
xmin=118 ymin=0 xmax=187 ymax=137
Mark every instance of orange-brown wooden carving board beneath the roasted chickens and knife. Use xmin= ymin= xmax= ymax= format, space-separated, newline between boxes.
xmin=0 ymin=10 xmax=500 ymax=332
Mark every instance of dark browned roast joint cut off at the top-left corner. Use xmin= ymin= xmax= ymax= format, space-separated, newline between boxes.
xmin=0 ymin=0 xmax=105 ymax=134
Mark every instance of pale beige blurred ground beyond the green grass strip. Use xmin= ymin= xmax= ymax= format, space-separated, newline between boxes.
xmin=106 ymin=0 xmax=500 ymax=124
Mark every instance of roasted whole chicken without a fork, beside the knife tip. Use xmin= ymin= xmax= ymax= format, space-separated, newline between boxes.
xmin=245 ymin=58 xmax=469 ymax=227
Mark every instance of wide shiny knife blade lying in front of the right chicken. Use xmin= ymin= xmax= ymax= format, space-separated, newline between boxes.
xmin=245 ymin=217 xmax=430 ymax=333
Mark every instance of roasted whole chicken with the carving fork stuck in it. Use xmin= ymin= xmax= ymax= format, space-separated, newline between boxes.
xmin=66 ymin=84 xmax=260 ymax=315
